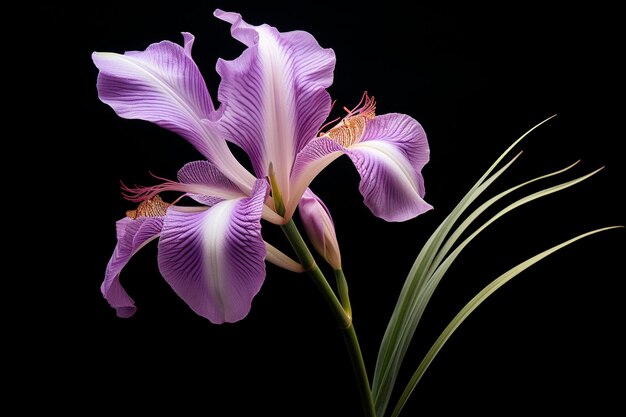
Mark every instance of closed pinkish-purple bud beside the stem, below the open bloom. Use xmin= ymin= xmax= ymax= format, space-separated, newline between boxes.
xmin=298 ymin=188 xmax=341 ymax=269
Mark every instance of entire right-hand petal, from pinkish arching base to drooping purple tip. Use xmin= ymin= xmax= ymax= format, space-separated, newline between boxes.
xmin=292 ymin=113 xmax=432 ymax=221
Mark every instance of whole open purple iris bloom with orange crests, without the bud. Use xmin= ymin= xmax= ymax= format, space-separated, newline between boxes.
xmin=92 ymin=10 xmax=432 ymax=323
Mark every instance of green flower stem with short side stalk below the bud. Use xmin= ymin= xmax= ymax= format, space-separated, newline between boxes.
xmin=282 ymin=220 xmax=376 ymax=417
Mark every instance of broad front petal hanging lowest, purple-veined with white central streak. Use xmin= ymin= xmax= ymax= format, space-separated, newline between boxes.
xmin=158 ymin=180 xmax=268 ymax=323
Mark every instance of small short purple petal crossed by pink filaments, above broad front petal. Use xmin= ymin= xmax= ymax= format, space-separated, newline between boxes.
xmin=178 ymin=161 xmax=242 ymax=207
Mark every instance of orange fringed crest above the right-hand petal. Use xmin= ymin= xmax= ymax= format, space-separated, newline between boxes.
xmin=320 ymin=91 xmax=376 ymax=148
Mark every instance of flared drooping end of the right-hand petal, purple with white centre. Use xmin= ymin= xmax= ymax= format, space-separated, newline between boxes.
xmin=346 ymin=113 xmax=432 ymax=221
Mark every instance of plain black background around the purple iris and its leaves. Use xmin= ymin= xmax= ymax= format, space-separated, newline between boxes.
xmin=26 ymin=1 xmax=626 ymax=416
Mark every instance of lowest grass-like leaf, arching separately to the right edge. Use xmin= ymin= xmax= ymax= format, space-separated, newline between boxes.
xmin=391 ymin=226 xmax=622 ymax=417
